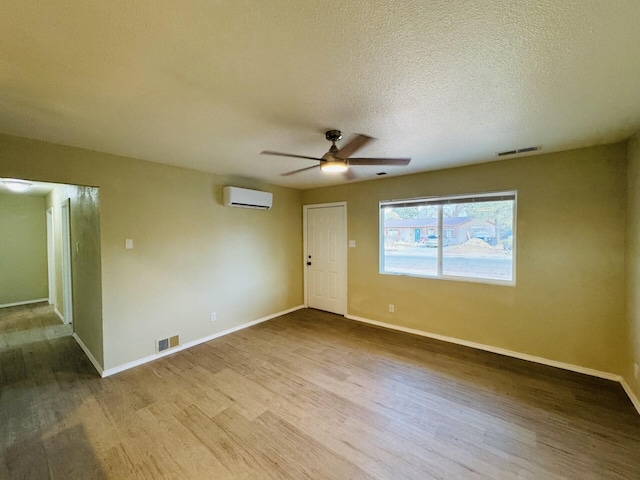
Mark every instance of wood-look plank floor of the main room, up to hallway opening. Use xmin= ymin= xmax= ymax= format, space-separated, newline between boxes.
xmin=0 ymin=310 xmax=640 ymax=480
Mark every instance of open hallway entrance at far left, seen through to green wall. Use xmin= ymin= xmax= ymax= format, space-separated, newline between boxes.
xmin=0 ymin=181 xmax=99 ymax=350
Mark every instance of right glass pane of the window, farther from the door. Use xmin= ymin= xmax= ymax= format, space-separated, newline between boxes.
xmin=442 ymin=200 xmax=514 ymax=281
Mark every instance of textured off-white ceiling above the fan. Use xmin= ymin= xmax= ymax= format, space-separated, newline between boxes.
xmin=0 ymin=0 xmax=640 ymax=188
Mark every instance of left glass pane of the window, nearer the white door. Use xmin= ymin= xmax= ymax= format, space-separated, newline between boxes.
xmin=382 ymin=205 xmax=438 ymax=276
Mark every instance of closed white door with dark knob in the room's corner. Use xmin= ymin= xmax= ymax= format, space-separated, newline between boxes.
xmin=305 ymin=205 xmax=347 ymax=315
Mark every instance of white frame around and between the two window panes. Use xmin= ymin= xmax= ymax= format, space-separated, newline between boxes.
xmin=378 ymin=189 xmax=518 ymax=286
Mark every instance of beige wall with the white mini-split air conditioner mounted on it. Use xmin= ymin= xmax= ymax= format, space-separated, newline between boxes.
xmin=0 ymin=135 xmax=302 ymax=368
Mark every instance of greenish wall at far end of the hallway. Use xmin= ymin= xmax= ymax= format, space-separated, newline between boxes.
xmin=0 ymin=193 xmax=49 ymax=305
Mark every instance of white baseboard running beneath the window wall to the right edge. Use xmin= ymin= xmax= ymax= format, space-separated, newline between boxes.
xmin=345 ymin=315 xmax=640 ymax=414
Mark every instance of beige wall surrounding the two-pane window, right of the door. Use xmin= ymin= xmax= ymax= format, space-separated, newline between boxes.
xmin=302 ymin=144 xmax=626 ymax=374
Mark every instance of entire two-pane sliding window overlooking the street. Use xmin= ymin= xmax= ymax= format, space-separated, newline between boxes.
xmin=380 ymin=191 xmax=516 ymax=285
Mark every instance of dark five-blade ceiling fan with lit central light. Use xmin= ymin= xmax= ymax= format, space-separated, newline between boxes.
xmin=260 ymin=130 xmax=411 ymax=179
